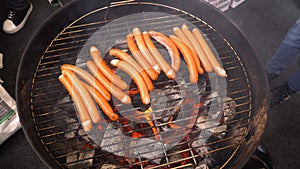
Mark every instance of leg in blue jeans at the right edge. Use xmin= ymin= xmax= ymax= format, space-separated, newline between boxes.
xmin=265 ymin=17 xmax=300 ymax=75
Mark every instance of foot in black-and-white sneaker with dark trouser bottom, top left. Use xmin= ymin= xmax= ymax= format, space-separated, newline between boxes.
xmin=2 ymin=0 xmax=33 ymax=34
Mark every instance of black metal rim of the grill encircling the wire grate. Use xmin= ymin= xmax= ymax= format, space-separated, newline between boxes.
xmin=16 ymin=0 xmax=268 ymax=168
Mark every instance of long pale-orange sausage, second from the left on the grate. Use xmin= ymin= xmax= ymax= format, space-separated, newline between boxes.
xmin=61 ymin=70 xmax=100 ymax=123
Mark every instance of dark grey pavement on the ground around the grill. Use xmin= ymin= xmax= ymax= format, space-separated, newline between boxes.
xmin=0 ymin=0 xmax=300 ymax=169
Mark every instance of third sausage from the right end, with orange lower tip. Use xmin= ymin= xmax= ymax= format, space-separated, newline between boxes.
xmin=173 ymin=27 xmax=204 ymax=74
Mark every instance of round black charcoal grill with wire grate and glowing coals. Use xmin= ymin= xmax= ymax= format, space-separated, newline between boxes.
xmin=16 ymin=0 xmax=268 ymax=169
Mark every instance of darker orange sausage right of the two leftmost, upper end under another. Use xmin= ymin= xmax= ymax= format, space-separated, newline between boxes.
xmin=84 ymin=83 xmax=119 ymax=121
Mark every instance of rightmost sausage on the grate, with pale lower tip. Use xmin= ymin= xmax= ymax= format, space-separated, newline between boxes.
xmin=193 ymin=28 xmax=227 ymax=77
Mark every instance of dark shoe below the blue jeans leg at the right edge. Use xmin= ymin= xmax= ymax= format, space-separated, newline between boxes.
xmin=270 ymin=82 xmax=296 ymax=107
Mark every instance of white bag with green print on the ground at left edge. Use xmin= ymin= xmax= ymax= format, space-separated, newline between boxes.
xmin=0 ymin=85 xmax=21 ymax=145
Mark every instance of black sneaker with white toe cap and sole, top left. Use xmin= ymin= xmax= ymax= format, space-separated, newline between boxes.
xmin=2 ymin=4 xmax=33 ymax=34
